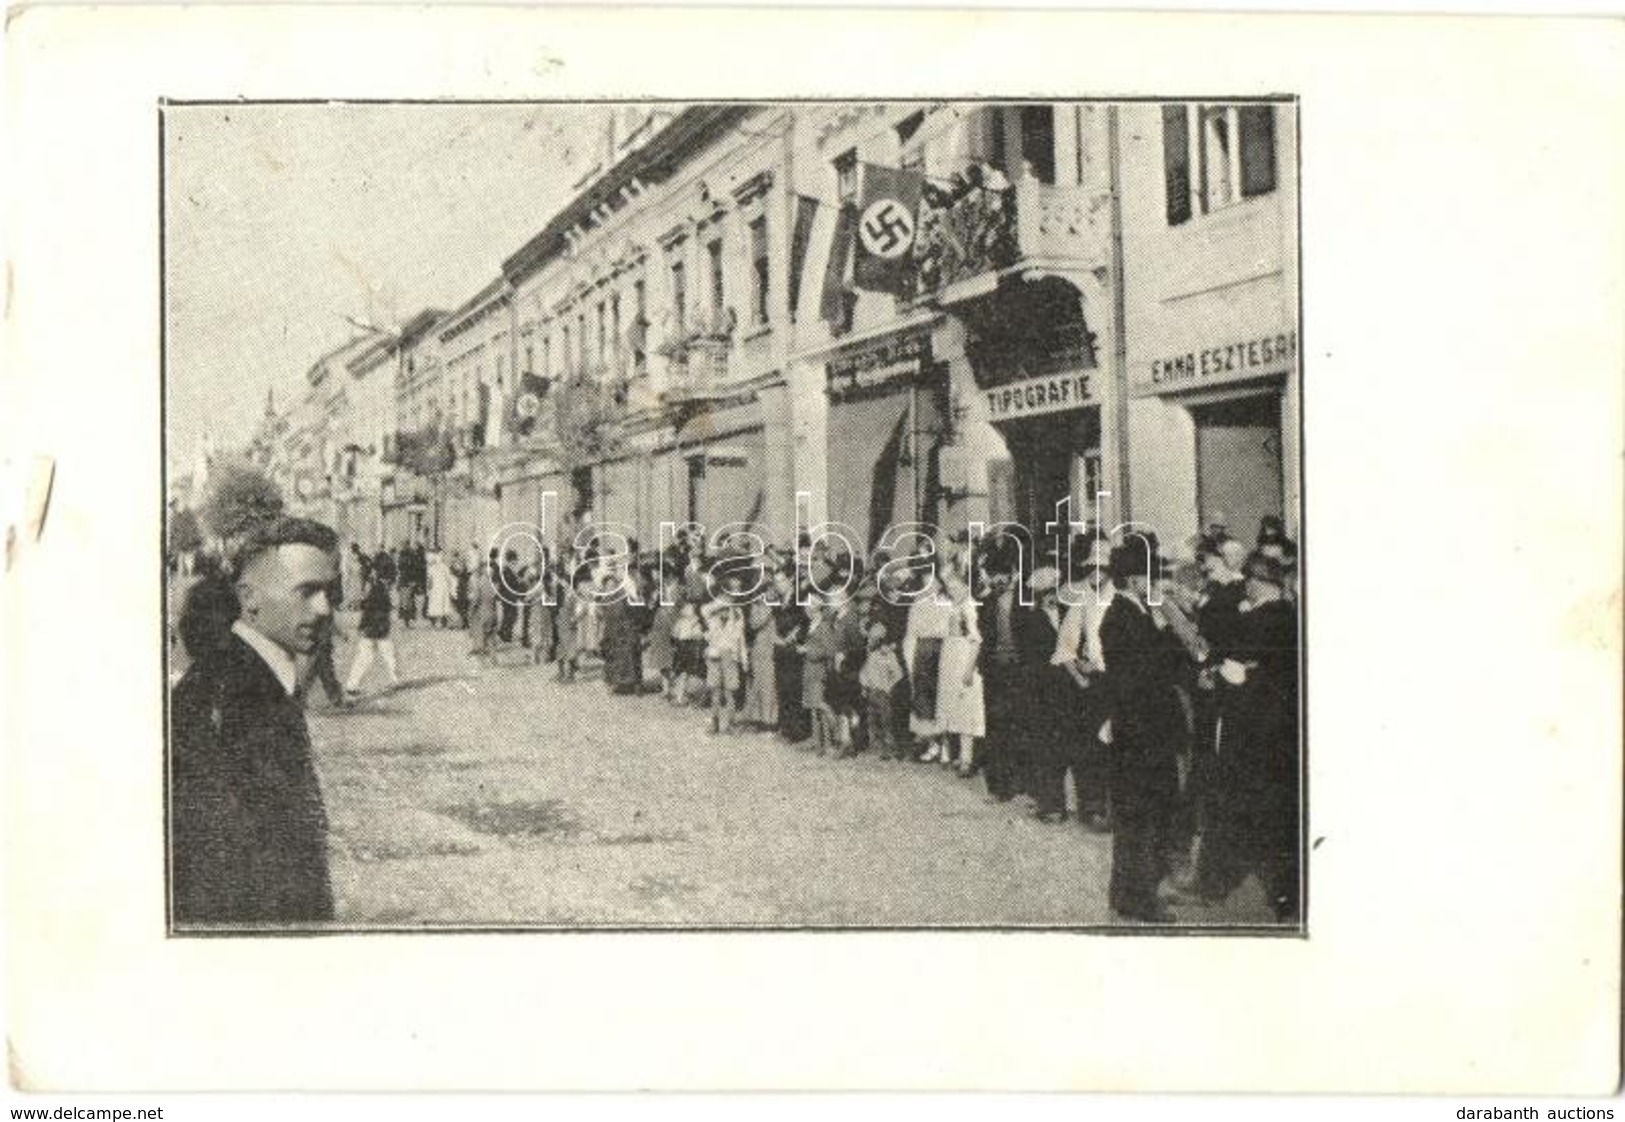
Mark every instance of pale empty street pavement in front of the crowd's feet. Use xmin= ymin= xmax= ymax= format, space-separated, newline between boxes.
xmin=299 ymin=624 xmax=1263 ymax=927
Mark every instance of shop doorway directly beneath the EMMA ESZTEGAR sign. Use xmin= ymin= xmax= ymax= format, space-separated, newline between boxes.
xmin=1191 ymin=392 xmax=1282 ymax=543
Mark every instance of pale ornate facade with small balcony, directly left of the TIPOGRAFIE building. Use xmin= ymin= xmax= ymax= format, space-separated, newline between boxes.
xmin=497 ymin=106 xmax=793 ymax=546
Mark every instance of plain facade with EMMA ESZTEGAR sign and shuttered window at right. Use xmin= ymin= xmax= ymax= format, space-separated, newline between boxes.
xmin=1121 ymin=102 xmax=1302 ymax=541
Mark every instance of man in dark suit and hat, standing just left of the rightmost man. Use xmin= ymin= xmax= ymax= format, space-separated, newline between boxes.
xmin=1100 ymin=535 xmax=1190 ymax=924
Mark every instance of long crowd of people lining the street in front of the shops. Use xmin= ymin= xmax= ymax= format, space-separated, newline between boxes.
xmin=345 ymin=519 xmax=1300 ymax=922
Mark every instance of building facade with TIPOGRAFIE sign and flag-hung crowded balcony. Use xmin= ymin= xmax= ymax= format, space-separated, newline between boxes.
xmin=780 ymin=102 xmax=1118 ymax=550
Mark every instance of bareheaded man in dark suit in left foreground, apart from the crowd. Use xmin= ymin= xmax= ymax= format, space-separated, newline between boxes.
xmin=171 ymin=517 xmax=338 ymax=927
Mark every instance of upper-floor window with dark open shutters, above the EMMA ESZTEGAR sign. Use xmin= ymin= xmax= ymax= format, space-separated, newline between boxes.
xmin=1162 ymin=104 xmax=1276 ymax=226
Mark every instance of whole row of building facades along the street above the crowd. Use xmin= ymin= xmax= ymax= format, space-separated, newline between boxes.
xmin=247 ymin=102 xmax=1300 ymax=569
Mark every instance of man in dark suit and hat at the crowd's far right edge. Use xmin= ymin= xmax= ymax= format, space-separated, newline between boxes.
xmin=1196 ymin=553 xmax=1300 ymax=922
